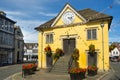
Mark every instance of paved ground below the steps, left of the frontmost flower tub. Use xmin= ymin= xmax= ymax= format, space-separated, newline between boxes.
xmin=13 ymin=71 xmax=70 ymax=80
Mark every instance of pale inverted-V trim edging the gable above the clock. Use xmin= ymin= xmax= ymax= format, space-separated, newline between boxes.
xmin=51 ymin=4 xmax=86 ymax=27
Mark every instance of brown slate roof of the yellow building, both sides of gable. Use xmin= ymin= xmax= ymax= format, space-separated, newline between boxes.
xmin=35 ymin=8 xmax=113 ymax=30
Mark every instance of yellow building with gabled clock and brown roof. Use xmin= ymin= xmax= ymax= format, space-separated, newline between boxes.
xmin=35 ymin=4 xmax=112 ymax=71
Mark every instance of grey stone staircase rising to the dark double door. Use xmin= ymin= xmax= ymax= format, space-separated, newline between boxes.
xmin=51 ymin=56 xmax=70 ymax=74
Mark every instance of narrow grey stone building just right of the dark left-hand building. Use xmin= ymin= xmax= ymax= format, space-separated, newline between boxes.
xmin=14 ymin=26 xmax=24 ymax=63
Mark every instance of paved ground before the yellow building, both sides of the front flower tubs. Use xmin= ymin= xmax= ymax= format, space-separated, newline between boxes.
xmin=12 ymin=70 xmax=108 ymax=80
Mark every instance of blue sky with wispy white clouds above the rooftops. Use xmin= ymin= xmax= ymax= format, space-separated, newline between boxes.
xmin=0 ymin=0 xmax=120 ymax=43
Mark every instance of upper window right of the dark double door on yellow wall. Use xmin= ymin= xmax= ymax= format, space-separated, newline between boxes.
xmin=87 ymin=29 xmax=97 ymax=40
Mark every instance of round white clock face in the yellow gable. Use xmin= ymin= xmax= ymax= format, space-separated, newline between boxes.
xmin=62 ymin=11 xmax=75 ymax=25
